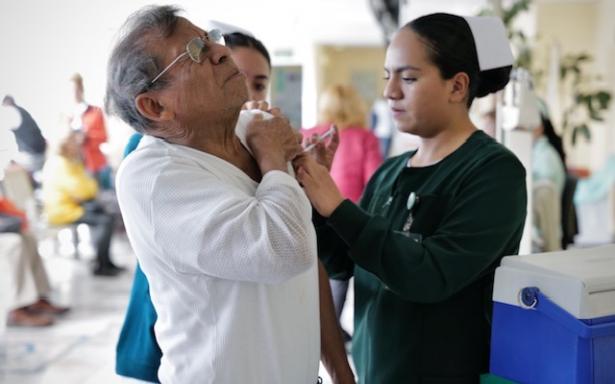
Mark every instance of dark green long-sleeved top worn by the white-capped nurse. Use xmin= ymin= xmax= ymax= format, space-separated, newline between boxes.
xmin=315 ymin=131 xmax=527 ymax=384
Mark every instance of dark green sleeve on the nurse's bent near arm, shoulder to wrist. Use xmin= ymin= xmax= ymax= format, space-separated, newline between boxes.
xmin=328 ymin=155 xmax=527 ymax=303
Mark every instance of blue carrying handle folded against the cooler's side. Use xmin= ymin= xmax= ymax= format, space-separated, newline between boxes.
xmin=519 ymin=287 xmax=615 ymax=338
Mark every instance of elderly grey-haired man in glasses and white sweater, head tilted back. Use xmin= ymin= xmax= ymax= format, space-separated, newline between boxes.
xmin=107 ymin=6 xmax=353 ymax=384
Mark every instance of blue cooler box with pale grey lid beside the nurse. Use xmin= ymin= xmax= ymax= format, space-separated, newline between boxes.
xmin=490 ymin=245 xmax=615 ymax=384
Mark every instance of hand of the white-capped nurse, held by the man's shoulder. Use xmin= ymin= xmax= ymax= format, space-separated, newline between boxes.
xmin=293 ymin=153 xmax=344 ymax=217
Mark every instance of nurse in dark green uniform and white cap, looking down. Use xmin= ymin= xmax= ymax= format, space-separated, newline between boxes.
xmin=295 ymin=13 xmax=526 ymax=384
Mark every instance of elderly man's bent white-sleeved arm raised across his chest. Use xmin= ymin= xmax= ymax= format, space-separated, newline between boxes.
xmin=150 ymin=166 xmax=315 ymax=283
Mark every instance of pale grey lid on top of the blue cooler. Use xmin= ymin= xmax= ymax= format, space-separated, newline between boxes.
xmin=493 ymin=245 xmax=615 ymax=319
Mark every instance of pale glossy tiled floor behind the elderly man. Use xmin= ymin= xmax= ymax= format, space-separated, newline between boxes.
xmin=0 ymin=230 xmax=352 ymax=384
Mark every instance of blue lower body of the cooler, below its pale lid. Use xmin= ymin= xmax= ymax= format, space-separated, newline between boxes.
xmin=490 ymin=288 xmax=615 ymax=384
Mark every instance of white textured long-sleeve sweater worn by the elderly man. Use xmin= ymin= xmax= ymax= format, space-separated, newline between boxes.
xmin=117 ymin=136 xmax=320 ymax=384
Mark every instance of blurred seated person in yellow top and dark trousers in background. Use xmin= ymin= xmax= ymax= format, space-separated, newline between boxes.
xmin=43 ymin=131 xmax=121 ymax=276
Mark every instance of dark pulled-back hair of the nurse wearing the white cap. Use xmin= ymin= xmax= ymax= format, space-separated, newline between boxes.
xmin=404 ymin=13 xmax=512 ymax=107
